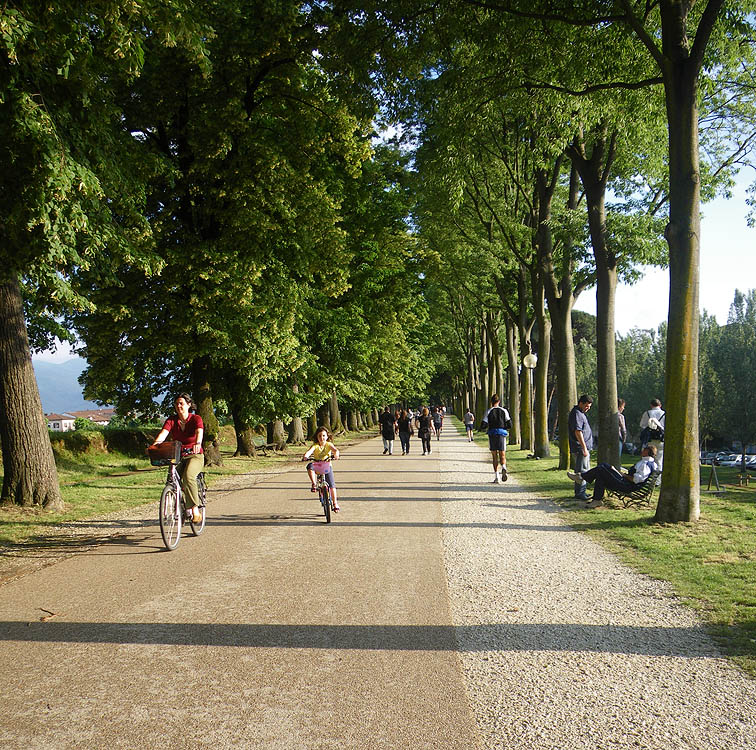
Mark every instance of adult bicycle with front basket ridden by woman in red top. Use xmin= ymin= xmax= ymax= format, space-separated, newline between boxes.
xmin=147 ymin=440 xmax=207 ymax=550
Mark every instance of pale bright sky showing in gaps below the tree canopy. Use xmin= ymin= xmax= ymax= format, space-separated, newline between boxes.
xmin=34 ymin=174 xmax=756 ymax=362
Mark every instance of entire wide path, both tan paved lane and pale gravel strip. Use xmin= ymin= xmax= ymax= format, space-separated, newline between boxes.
xmin=0 ymin=428 xmax=756 ymax=750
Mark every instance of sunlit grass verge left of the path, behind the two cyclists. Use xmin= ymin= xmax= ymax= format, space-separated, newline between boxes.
xmin=0 ymin=430 xmax=375 ymax=554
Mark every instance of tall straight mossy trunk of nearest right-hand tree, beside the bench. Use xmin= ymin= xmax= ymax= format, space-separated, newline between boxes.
xmin=656 ymin=35 xmax=701 ymax=523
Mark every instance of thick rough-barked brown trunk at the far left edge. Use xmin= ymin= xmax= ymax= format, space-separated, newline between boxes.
xmin=0 ymin=272 xmax=63 ymax=511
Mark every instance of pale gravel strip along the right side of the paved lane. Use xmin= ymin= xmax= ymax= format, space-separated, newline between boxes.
xmin=440 ymin=430 xmax=756 ymax=750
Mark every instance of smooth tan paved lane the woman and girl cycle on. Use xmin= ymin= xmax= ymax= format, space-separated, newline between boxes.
xmin=0 ymin=437 xmax=480 ymax=750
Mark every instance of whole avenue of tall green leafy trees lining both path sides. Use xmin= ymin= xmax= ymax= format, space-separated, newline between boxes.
xmin=0 ymin=0 xmax=756 ymax=521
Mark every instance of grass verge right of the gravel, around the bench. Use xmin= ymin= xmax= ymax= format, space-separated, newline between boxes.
xmin=459 ymin=420 xmax=756 ymax=676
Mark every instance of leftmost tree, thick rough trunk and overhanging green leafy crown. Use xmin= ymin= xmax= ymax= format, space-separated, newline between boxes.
xmin=0 ymin=2 xmax=202 ymax=508
